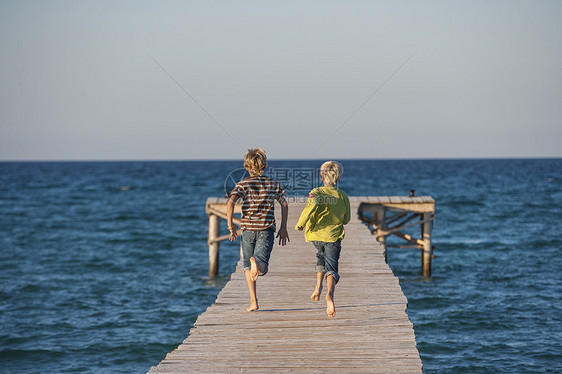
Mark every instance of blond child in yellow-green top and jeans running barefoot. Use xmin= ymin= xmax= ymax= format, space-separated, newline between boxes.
xmin=295 ymin=161 xmax=351 ymax=318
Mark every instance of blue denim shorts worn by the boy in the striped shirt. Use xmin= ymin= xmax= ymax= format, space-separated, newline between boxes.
xmin=241 ymin=227 xmax=275 ymax=275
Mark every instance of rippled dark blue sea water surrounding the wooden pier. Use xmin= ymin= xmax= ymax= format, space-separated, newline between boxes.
xmin=0 ymin=159 xmax=562 ymax=373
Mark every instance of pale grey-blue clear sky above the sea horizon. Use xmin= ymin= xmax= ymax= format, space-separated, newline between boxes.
xmin=0 ymin=0 xmax=562 ymax=161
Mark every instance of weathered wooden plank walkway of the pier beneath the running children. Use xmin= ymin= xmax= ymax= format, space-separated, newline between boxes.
xmin=149 ymin=198 xmax=422 ymax=373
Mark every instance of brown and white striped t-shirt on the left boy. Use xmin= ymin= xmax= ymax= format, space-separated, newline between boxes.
xmin=230 ymin=176 xmax=285 ymax=231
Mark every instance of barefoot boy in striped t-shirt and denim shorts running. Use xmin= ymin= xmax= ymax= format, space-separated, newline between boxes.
xmin=226 ymin=148 xmax=289 ymax=312
